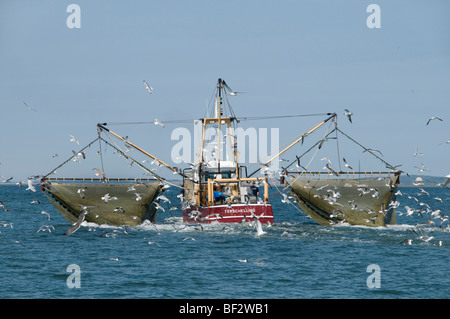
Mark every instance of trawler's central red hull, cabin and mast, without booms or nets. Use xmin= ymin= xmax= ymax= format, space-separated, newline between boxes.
xmin=181 ymin=79 xmax=273 ymax=224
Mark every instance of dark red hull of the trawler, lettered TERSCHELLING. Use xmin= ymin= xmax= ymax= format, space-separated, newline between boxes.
xmin=183 ymin=204 xmax=273 ymax=224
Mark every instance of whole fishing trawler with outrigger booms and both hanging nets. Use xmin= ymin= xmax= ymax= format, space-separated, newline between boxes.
xmin=42 ymin=79 xmax=400 ymax=226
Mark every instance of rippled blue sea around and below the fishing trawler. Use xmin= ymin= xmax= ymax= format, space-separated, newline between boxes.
xmin=0 ymin=185 xmax=450 ymax=299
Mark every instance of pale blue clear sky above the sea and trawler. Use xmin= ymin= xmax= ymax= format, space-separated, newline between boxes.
xmin=0 ymin=0 xmax=450 ymax=180
